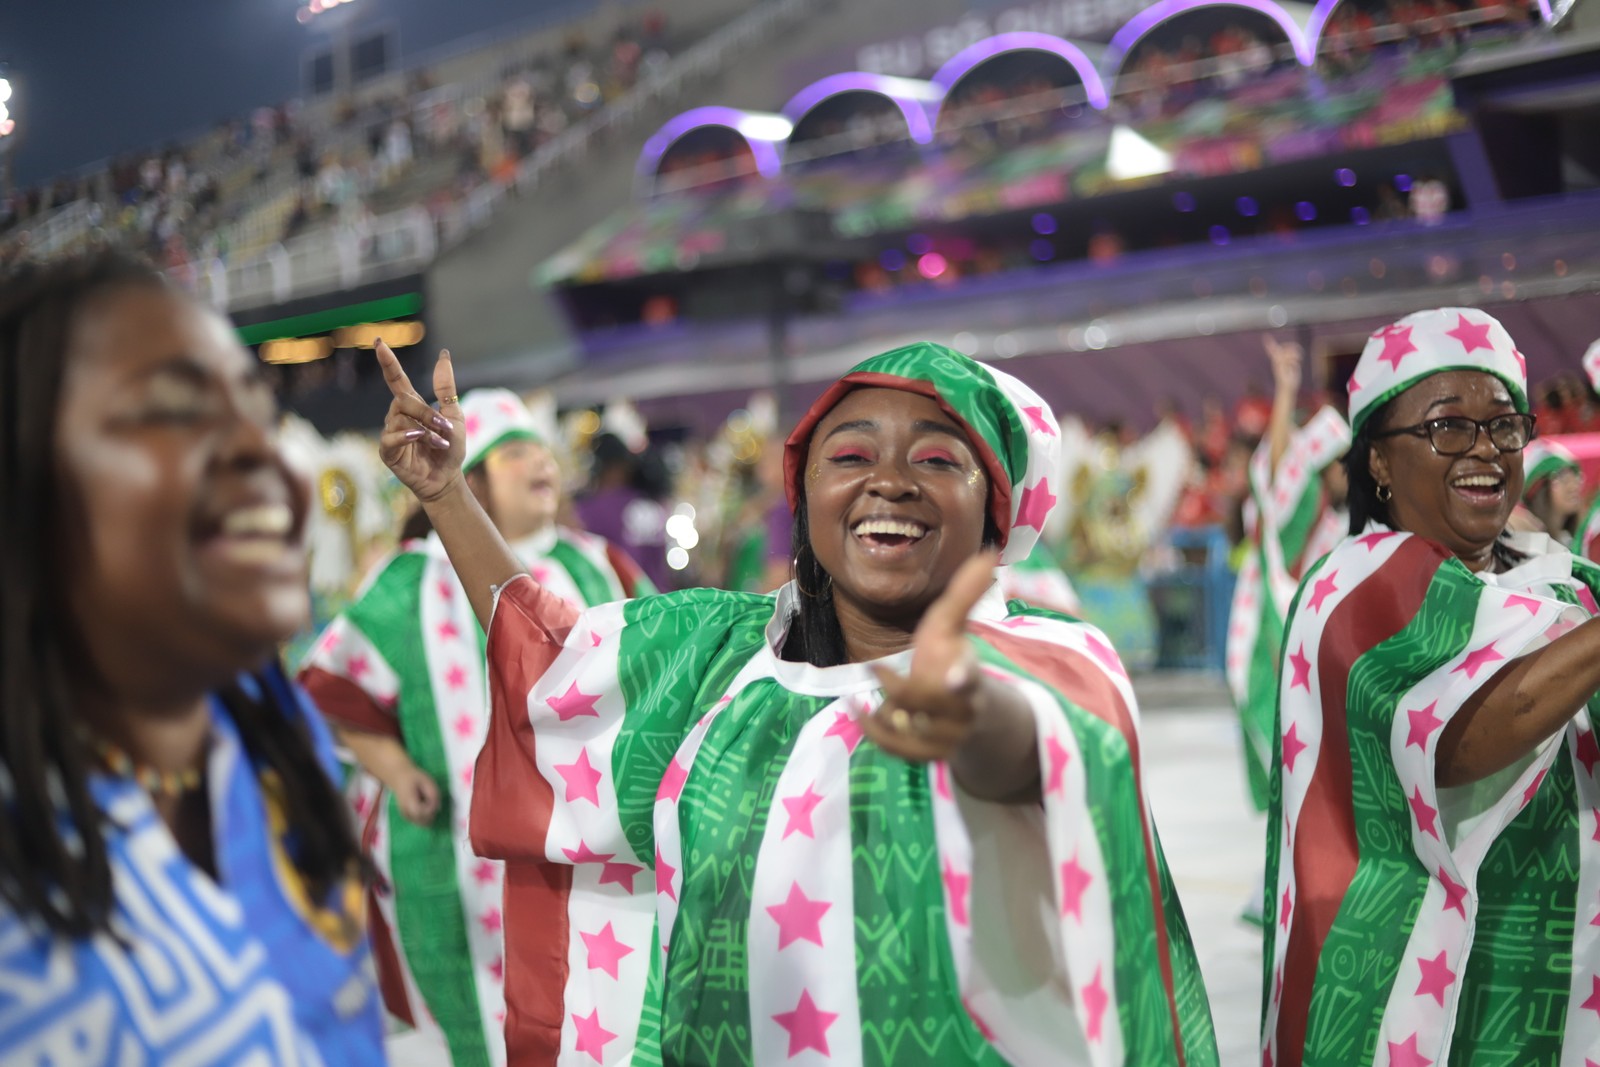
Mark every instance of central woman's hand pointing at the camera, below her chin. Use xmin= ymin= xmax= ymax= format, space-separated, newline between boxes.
xmin=862 ymin=552 xmax=997 ymax=763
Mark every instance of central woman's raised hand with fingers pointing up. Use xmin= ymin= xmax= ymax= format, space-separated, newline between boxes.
xmin=374 ymin=341 xmax=467 ymax=504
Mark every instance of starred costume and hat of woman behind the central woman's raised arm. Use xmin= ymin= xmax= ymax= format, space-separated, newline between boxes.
xmin=301 ymin=390 xmax=654 ymax=1067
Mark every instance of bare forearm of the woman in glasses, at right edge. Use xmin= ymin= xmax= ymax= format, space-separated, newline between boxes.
xmin=1434 ymin=619 xmax=1600 ymax=785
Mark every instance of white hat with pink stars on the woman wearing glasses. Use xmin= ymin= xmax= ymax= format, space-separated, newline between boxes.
xmin=1349 ymin=307 xmax=1528 ymax=434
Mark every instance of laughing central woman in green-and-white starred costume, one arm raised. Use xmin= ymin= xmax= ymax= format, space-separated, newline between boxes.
xmin=379 ymin=337 xmax=1216 ymax=1067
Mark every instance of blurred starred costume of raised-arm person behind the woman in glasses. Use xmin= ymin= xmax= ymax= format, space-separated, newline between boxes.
xmin=1226 ymin=408 xmax=1350 ymax=811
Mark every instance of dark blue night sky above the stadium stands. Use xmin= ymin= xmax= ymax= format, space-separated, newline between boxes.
xmin=0 ymin=0 xmax=597 ymax=186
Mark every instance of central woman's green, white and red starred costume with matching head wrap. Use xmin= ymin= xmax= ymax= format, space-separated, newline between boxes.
xmin=472 ymin=346 xmax=1216 ymax=1067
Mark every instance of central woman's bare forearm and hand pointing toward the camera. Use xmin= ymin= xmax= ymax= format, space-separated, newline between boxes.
xmin=862 ymin=553 xmax=1042 ymax=803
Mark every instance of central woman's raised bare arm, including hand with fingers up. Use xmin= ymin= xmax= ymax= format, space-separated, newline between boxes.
xmin=376 ymin=341 xmax=523 ymax=630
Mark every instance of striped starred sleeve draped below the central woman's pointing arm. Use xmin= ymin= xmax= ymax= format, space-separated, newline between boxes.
xmin=930 ymin=613 xmax=1216 ymax=1067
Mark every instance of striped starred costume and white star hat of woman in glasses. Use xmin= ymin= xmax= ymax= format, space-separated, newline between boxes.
xmin=1262 ymin=309 xmax=1600 ymax=1067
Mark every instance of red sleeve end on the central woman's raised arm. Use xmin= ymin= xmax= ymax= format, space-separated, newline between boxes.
xmin=467 ymin=574 xmax=578 ymax=861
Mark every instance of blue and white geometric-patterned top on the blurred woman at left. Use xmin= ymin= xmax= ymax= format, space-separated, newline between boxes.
xmin=0 ymin=673 xmax=384 ymax=1067
